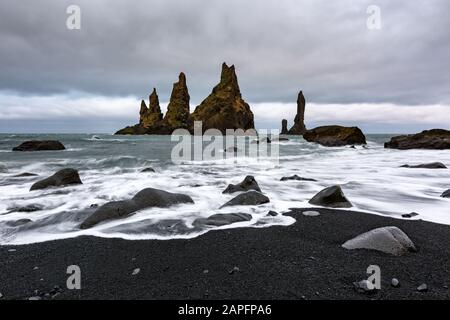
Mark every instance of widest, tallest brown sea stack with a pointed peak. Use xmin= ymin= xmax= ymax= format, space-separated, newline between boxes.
xmin=191 ymin=63 xmax=255 ymax=134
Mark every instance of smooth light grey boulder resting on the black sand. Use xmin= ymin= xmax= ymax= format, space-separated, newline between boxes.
xmin=342 ymin=227 xmax=417 ymax=256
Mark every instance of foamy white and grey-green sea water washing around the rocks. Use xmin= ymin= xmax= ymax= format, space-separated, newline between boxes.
xmin=0 ymin=134 xmax=450 ymax=244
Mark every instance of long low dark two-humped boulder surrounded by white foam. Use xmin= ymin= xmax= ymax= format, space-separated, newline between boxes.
xmin=80 ymin=188 xmax=194 ymax=229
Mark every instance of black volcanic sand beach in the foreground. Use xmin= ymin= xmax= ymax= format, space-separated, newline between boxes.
xmin=0 ymin=209 xmax=450 ymax=299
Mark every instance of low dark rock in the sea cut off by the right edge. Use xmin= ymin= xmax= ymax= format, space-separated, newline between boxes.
xmin=384 ymin=129 xmax=450 ymax=150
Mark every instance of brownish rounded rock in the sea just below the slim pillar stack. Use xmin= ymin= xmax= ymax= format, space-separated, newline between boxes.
xmin=303 ymin=126 xmax=366 ymax=147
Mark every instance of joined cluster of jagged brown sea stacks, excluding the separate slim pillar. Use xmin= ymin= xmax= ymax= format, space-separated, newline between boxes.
xmin=116 ymin=63 xmax=255 ymax=134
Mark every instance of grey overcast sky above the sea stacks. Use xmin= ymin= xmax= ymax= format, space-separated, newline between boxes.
xmin=0 ymin=0 xmax=450 ymax=133
